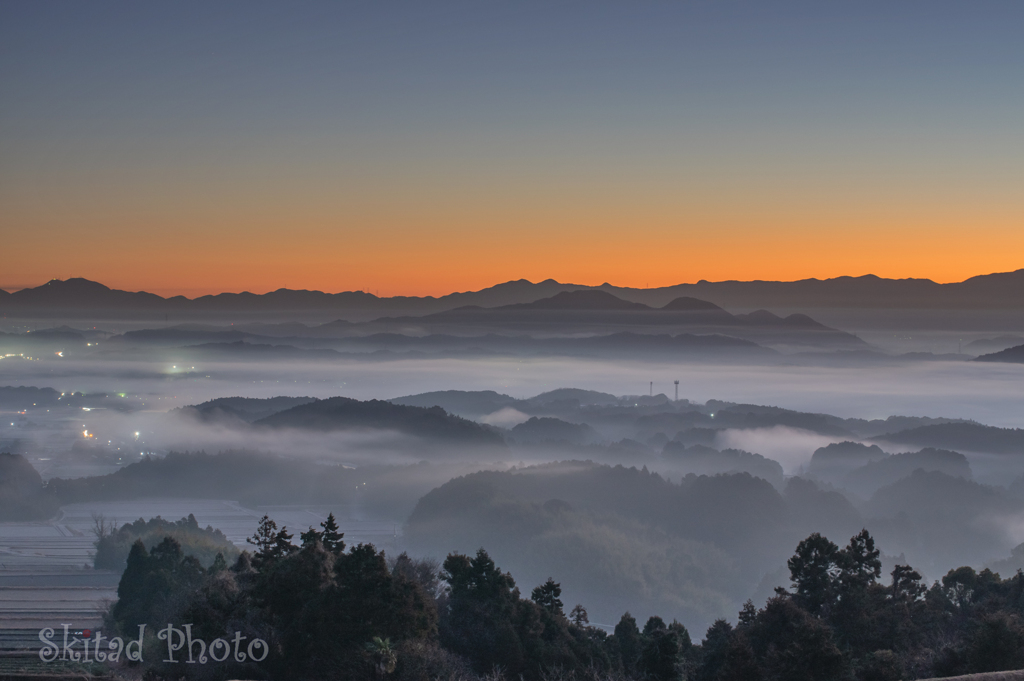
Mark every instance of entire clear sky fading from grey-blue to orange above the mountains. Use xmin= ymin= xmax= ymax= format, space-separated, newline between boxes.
xmin=0 ymin=0 xmax=1024 ymax=295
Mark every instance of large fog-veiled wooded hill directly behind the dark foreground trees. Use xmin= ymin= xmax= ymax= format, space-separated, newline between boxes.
xmin=406 ymin=461 xmax=861 ymax=625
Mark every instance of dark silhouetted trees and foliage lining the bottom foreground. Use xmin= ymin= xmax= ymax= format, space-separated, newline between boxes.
xmin=110 ymin=516 xmax=1024 ymax=681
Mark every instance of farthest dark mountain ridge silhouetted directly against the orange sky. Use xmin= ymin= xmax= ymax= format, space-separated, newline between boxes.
xmin=0 ymin=269 xmax=1024 ymax=317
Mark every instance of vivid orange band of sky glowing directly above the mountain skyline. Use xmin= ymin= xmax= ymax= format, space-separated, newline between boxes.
xmin=0 ymin=220 xmax=1024 ymax=298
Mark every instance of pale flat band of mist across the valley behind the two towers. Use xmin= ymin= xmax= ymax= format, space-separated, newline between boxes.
xmin=0 ymin=356 xmax=1024 ymax=427
